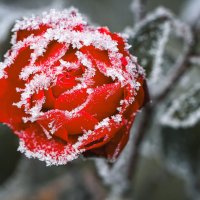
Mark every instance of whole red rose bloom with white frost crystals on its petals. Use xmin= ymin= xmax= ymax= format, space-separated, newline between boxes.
xmin=0 ymin=9 xmax=147 ymax=165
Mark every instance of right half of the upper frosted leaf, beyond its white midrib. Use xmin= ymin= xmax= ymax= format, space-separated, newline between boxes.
xmin=152 ymin=18 xmax=193 ymax=97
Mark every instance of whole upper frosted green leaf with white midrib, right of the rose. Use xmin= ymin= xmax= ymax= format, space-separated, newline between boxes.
xmin=126 ymin=8 xmax=192 ymax=96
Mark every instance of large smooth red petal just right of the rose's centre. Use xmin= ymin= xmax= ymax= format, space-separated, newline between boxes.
xmin=84 ymin=83 xmax=123 ymax=120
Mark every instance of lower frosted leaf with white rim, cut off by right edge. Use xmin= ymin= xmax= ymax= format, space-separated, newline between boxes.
xmin=161 ymin=84 xmax=200 ymax=128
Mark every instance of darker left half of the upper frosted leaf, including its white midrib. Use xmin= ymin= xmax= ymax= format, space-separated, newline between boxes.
xmin=126 ymin=8 xmax=172 ymax=83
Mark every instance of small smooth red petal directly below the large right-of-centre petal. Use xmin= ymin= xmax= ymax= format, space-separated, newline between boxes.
xmin=66 ymin=111 xmax=98 ymax=135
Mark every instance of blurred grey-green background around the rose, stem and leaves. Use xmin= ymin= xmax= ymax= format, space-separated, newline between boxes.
xmin=0 ymin=0 xmax=200 ymax=200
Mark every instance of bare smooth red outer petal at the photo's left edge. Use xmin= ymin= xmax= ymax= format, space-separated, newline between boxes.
xmin=0 ymin=47 xmax=32 ymax=130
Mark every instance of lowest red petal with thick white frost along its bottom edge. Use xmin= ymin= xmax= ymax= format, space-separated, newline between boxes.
xmin=18 ymin=124 xmax=80 ymax=165
